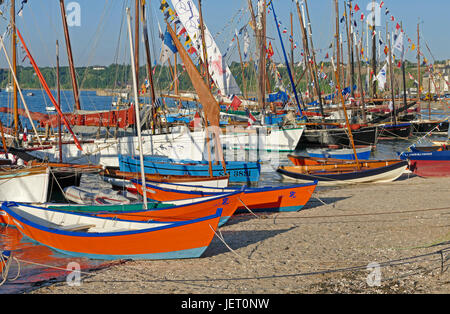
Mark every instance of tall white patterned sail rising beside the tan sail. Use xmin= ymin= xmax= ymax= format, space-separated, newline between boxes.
xmin=171 ymin=0 xmax=242 ymax=96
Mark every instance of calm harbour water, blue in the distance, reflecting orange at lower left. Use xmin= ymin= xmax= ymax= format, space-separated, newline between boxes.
xmin=0 ymin=91 xmax=445 ymax=294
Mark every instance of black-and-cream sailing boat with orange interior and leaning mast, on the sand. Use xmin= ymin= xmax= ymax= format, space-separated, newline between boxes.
xmin=277 ymin=0 xmax=407 ymax=185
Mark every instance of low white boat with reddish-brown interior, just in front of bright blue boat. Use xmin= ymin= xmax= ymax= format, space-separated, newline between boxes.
xmin=102 ymin=168 xmax=229 ymax=189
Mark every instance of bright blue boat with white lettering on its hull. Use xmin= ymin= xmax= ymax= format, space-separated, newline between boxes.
xmin=119 ymin=155 xmax=261 ymax=183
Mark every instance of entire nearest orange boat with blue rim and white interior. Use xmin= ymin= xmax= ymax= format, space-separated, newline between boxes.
xmin=1 ymin=202 xmax=222 ymax=260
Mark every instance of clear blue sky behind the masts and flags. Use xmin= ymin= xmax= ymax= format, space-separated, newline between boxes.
xmin=0 ymin=0 xmax=450 ymax=68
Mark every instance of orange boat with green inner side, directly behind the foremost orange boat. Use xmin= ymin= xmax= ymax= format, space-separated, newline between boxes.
xmin=44 ymin=190 xmax=243 ymax=227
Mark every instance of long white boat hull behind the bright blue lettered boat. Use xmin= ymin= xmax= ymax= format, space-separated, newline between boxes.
xmin=30 ymin=127 xmax=304 ymax=167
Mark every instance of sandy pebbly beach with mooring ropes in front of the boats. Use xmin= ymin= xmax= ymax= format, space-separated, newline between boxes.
xmin=30 ymin=174 xmax=450 ymax=294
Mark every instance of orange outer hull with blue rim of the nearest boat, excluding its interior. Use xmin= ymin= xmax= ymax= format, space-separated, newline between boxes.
xmin=2 ymin=203 xmax=221 ymax=259
